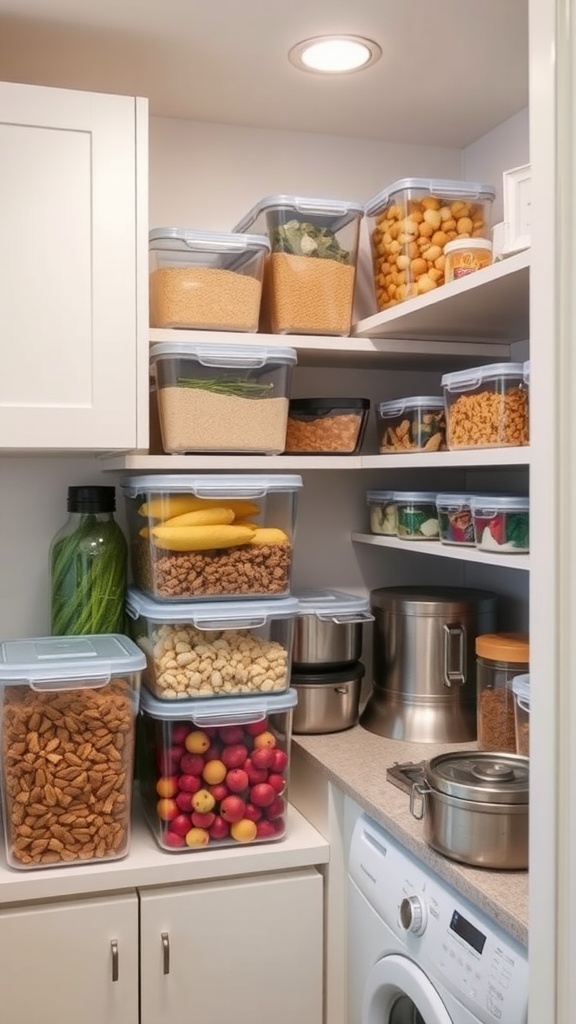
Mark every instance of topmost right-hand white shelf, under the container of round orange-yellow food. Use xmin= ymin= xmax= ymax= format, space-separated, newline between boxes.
xmin=353 ymin=250 xmax=530 ymax=346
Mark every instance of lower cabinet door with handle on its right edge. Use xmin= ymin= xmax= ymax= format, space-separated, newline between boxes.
xmin=0 ymin=894 xmax=138 ymax=1024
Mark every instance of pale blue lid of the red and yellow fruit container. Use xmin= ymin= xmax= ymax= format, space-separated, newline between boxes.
xmin=140 ymin=686 xmax=298 ymax=727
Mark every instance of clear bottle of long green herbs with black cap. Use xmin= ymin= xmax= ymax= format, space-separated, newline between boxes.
xmin=50 ymin=485 xmax=128 ymax=636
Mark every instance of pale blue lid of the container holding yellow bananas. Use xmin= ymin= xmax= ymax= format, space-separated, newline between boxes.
xmin=120 ymin=473 xmax=302 ymax=498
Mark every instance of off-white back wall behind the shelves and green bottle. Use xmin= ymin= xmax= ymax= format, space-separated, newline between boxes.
xmin=0 ymin=108 xmax=528 ymax=638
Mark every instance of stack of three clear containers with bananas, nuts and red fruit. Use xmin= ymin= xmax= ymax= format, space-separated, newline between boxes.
xmin=122 ymin=474 xmax=301 ymax=851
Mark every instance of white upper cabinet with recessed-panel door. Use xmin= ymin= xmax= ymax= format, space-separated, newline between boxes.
xmin=0 ymin=83 xmax=148 ymax=451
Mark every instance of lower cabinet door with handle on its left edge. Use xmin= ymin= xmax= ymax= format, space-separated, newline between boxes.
xmin=136 ymin=869 xmax=323 ymax=1024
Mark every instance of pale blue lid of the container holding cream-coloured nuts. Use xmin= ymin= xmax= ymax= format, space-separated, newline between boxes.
xmin=126 ymin=587 xmax=300 ymax=630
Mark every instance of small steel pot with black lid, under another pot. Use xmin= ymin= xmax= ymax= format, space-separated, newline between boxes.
xmin=290 ymin=662 xmax=365 ymax=734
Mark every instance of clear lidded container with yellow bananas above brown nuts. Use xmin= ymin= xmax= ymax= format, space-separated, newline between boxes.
xmin=121 ymin=473 xmax=302 ymax=601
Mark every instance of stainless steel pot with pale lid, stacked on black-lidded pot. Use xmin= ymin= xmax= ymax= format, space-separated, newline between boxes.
xmin=292 ymin=590 xmax=374 ymax=672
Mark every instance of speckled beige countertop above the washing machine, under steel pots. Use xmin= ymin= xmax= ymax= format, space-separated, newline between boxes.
xmin=293 ymin=725 xmax=528 ymax=946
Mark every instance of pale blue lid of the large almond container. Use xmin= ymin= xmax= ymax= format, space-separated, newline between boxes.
xmin=0 ymin=633 xmax=146 ymax=688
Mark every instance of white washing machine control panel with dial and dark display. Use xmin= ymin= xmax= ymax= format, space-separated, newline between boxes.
xmin=349 ymin=817 xmax=528 ymax=1024
